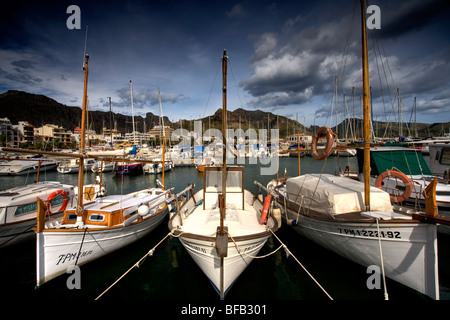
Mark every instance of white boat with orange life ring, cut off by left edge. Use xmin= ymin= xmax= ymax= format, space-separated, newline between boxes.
xmin=0 ymin=181 xmax=76 ymax=248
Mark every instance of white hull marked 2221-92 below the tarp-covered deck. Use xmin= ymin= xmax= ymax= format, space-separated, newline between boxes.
xmin=278 ymin=203 xmax=439 ymax=299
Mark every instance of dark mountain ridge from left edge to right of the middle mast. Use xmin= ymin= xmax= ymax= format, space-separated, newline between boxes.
xmin=0 ymin=90 xmax=305 ymax=135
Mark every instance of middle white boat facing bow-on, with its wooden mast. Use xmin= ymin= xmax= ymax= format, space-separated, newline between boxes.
xmin=169 ymin=51 xmax=278 ymax=299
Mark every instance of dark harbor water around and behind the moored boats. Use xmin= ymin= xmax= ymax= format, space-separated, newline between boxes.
xmin=0 ymin=157 xmax=450 ymax=302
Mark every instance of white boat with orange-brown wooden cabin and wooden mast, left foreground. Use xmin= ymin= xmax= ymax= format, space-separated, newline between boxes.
xmin=36 ymin=55 xmax=172 ymax=286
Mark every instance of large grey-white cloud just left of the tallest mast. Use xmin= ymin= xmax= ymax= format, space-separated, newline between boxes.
xmin=241 ymin=12 xmax=354 ymax=107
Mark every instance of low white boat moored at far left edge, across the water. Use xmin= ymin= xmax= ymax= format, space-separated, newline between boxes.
xmin=0 ymin=156 xmax=58 ymax=176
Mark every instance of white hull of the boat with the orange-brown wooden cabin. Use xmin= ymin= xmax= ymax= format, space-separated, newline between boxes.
xmin=36 ymin=206 xmax=169 ymax=286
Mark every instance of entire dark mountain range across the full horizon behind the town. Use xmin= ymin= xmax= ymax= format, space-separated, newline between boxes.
xmin=0 ymin=90 xmax=450 ymax=138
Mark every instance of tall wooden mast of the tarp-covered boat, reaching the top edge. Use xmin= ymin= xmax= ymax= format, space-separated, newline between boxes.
xmin=361 ymin=0 xmax=370 ymax=211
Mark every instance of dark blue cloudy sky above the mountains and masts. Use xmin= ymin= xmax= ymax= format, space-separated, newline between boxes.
xmin=0 ymin=0 xmax=450 ymax=125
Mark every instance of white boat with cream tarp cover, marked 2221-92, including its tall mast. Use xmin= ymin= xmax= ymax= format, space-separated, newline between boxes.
xmin=267 ymin=0 xmax=449 ymax=299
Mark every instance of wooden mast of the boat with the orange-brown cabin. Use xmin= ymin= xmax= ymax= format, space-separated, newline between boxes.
xmin=77 ymin=55 xmax=89 ymax=225
